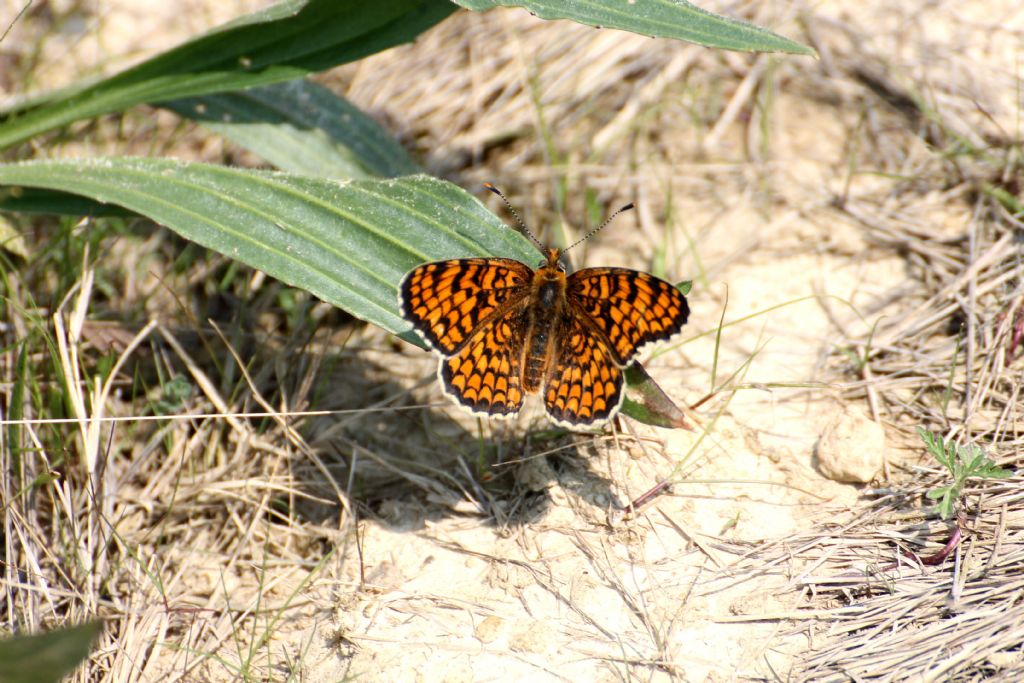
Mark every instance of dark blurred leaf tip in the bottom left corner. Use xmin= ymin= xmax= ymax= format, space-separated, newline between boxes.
xmin=0 ymin=621 xmax=103 ymax=683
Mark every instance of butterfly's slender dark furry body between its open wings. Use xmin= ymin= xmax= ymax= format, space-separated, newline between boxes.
xmin=521 ymin=249 xmax=568 ymax=393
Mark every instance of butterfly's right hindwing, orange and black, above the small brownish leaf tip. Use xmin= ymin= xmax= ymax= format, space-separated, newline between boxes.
xmin=544 ymin=316 xmax=623 ymax=427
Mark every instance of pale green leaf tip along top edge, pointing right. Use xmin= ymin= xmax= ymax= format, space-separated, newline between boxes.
xmin=454 ymin=0 xmax=814 ymax=55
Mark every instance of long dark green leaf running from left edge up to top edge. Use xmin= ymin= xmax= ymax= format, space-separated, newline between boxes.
xmin=0 ymin=0 xmax=455 ymax=148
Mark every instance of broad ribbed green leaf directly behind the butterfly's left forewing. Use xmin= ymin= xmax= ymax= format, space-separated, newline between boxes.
xmin=0 ymin=159 xmax=538 ymax=346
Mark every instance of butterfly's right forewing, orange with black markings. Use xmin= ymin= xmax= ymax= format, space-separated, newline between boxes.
xmin=566 ymin=268 xmax=690 ymax=367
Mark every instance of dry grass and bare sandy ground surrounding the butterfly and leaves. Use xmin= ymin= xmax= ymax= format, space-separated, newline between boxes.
xmin=0 ymin=2 xmax=1024 ymax=681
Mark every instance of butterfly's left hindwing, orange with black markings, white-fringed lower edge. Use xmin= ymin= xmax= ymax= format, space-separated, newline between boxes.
xmin=438 ymin=305 xmax=524 ymax=416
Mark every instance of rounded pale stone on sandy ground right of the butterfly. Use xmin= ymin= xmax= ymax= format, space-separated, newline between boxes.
xmin=817 ymin=409 xmax=886 ymax=483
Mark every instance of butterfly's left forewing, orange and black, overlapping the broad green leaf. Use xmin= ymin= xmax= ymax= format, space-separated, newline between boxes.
xmin=398 ymin=258 xmax=534 ymax=355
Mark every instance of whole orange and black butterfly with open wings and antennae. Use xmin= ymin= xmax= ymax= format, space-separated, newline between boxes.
xmin=398 ymin=184 xmax=689 ymax=427
